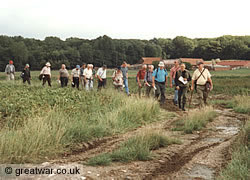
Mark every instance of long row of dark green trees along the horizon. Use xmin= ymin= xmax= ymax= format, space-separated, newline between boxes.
xmin=0 ymin=35 xmax=250 ymax=71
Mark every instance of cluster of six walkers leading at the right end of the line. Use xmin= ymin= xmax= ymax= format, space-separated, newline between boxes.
xmin=136 ymin=61 xmax=213 ymax=111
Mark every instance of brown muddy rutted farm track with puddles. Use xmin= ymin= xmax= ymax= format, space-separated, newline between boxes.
xmin=10 ymin=95 xmax=247 ymax=180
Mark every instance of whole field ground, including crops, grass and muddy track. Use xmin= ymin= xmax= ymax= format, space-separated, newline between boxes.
xmin=0 ymin=69 xmax=250 ymax=179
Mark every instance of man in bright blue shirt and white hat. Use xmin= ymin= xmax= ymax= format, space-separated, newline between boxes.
xmin=152 ymin=61 xmax=168 ymax=105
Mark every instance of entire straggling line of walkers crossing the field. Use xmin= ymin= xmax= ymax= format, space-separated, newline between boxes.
xmin=5 ymin=60 xmax=213 ymax=111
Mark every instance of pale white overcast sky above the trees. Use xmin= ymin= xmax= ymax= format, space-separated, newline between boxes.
xmin=0 ymin=0 xmax=250 ymax=39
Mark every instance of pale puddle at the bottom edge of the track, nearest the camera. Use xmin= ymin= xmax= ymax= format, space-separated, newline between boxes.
xmin=187 ymin=164 xmax=215 ymax=179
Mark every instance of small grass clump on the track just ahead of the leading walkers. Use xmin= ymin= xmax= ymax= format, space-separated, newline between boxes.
xmin=173 ymin=107 xmax=216 ymax=133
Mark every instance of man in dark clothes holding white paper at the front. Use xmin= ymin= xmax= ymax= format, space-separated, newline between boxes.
xmin=174 ymin=63 xmax=191 ymax=111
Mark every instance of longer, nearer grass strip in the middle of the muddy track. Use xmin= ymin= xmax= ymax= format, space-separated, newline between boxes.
xmin=87 ymin=132 xmax=180 ymax=166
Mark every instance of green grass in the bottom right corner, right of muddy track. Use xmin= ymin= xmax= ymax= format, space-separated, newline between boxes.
xmin=217 ymin=120 xmax=250 ymax=180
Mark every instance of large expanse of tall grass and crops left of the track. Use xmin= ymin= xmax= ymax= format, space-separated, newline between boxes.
xmin=0 ymin=84 xmax=161 ymax=163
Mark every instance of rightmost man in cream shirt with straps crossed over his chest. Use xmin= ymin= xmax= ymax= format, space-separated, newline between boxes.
xmin=191 ymin=61 xmax=213 ymax=108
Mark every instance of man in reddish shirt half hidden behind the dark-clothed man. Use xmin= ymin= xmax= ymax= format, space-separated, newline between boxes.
xmin=169 ymin=60 xmax=180 ymax=105
